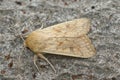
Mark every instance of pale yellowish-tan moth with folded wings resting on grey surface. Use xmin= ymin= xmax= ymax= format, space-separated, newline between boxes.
xmin=24 ymin=18 xmax=96 ymax=71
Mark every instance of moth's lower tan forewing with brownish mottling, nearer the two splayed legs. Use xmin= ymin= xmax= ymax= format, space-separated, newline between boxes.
xmin=42 ymin=35 xmax=95 ymax=58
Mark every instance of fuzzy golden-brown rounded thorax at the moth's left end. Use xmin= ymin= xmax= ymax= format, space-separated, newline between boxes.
xmin=24 ymin=31 xmax=45 ymax=53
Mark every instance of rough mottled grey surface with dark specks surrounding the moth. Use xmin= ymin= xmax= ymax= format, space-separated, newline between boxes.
xmin=0 ymin=0 xmax=120 ymax=80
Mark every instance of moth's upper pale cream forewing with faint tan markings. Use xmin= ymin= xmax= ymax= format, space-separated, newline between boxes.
xmin=32 ymin=18 xmax=90 ymax=37
